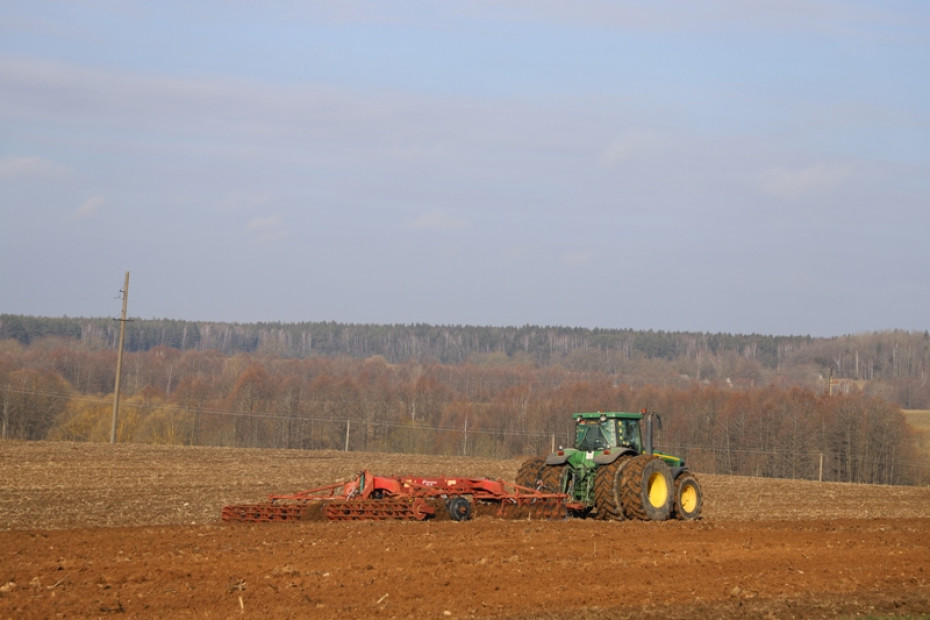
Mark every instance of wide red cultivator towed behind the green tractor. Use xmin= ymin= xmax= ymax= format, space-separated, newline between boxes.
xmin=223 ymin=471 xmax=582 ymax=523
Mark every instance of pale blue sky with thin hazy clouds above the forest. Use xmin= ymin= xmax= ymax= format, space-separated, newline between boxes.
xmin=0 ymin=0 xmax=930 ymax=337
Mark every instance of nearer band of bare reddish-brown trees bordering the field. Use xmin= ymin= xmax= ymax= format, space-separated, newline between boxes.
xmin=0 ymin=337 xmax=928 ymax=484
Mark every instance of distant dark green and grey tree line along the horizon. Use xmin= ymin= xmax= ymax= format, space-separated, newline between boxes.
xmin=0 ymin=314 xmax=930 ymax=409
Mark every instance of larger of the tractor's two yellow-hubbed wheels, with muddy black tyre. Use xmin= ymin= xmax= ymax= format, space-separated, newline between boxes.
xmin=620 ymin=454 xmax=675 ymax=521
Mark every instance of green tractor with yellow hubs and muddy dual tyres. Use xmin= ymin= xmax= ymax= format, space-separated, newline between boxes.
xmin=516 ymin=410 xmax=703 ymax=521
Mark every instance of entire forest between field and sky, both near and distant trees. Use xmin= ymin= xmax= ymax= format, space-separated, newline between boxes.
xmin=0 ymin=315 xmax=930 ymax=484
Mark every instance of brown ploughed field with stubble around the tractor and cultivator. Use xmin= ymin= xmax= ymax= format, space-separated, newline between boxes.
xmin=0 ymin=442 xmax=930 ymax=619
